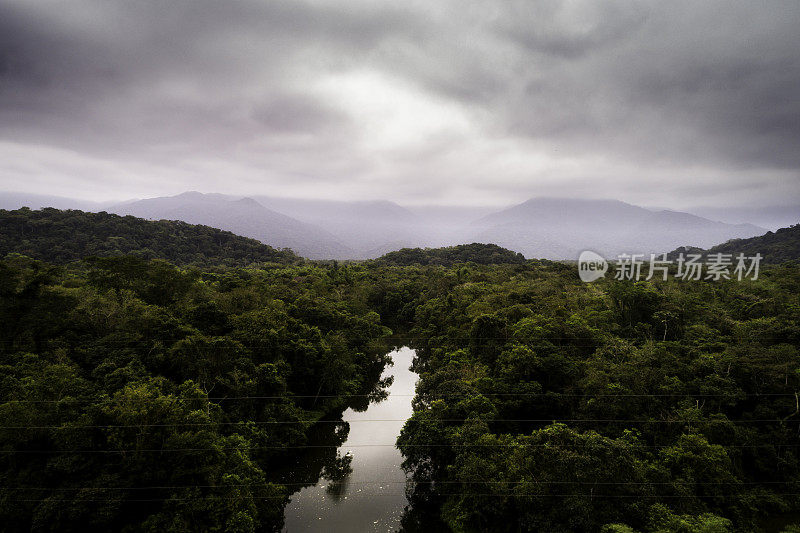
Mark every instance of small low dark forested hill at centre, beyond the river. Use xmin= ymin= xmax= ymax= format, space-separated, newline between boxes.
xmin=375 ymin=243 xmax=525 ymax=266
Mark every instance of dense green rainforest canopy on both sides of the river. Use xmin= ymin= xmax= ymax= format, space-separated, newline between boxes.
xmin=0 ymin=210 xmax=800 ymax=533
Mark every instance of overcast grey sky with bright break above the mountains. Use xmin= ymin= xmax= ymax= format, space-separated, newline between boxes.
xmin=0 ymin=0 xmax=800 ymax=208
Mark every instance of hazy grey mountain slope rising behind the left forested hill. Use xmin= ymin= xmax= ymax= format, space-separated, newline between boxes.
xmin=109 ymin=192 xmax=353 ymax=259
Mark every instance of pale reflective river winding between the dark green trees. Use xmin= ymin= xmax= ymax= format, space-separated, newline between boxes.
xmin=284 ymin=348 xmax=417 ymax=533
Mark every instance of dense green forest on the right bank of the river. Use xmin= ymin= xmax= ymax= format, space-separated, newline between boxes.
xmin=392 ymin=262 xmax=800 ymax=533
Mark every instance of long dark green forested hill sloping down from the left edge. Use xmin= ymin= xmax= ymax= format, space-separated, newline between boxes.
xmin=0 ymin=208 xmax=300 ymax=266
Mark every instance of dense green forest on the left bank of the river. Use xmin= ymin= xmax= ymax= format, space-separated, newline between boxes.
xmin=0 ymin=256 xmax=389 ymax=532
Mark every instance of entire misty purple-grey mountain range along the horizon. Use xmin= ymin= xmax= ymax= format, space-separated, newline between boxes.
xmin=0 ymin=191 xmax=767 ymax=259
